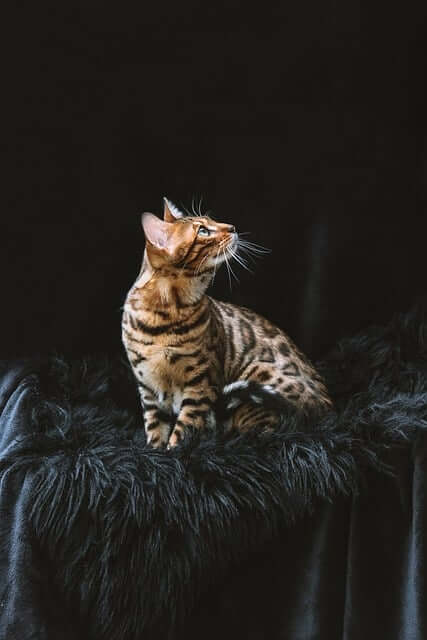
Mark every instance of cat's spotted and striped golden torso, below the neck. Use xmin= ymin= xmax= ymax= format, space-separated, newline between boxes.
xmin=122 ymin=286 xmax=330 ymax=440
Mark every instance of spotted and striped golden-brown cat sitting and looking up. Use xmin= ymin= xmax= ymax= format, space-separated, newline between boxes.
xmin=122 ymin=198 xmax=331 ymax=448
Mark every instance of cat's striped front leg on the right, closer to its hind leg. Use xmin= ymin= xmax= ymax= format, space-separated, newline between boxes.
xmin=168 ymin=386 xmax=218 ymax=449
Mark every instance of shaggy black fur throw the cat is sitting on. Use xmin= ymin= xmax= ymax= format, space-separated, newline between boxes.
xmin=0 ymin=306 xmax=427 ymax=640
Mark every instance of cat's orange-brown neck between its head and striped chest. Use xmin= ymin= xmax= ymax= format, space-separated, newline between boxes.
xmin=129 ymin=256 xmax=210 ymax=314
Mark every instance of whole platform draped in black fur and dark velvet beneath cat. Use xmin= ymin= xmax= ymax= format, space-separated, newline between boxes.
xmin=0 ymin=309 xmax=427 ymax=640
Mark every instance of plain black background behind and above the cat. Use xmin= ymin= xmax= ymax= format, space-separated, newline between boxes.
xmin=1 ymin=0 xmax=427 ymax=357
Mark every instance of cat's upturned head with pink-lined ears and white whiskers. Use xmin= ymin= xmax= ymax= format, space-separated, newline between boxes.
xmin=142 ymin=198 xmax=237 ymax=275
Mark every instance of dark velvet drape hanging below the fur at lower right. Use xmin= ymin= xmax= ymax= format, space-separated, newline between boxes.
xmin=186 ymin=438 xmax=427 ymax=640
